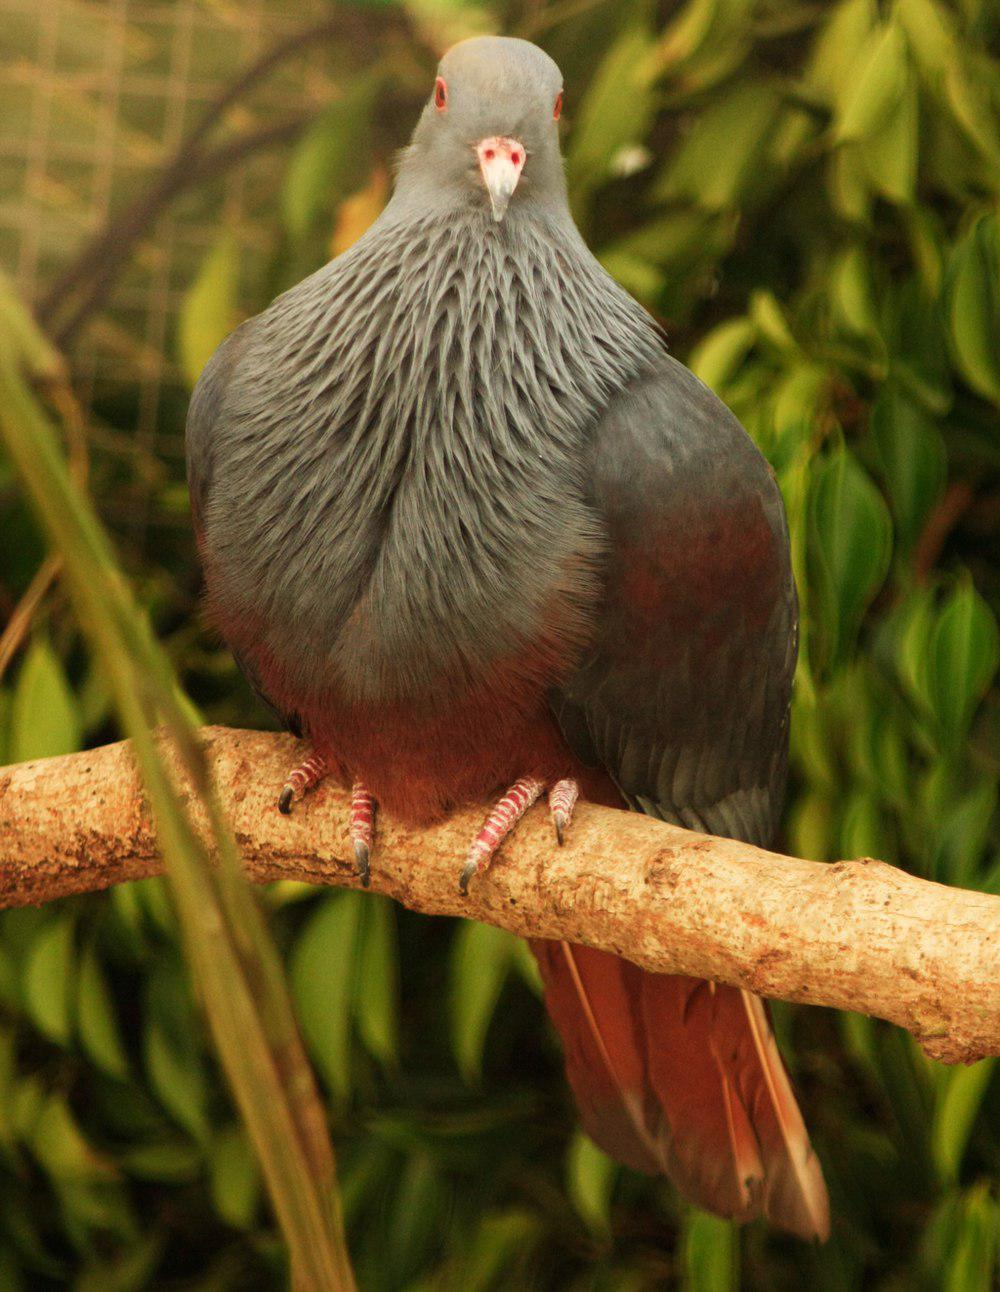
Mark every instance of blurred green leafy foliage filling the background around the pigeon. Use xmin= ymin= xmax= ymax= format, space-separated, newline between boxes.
xmin=0 ymin=0 xmax=1000 ymax=1292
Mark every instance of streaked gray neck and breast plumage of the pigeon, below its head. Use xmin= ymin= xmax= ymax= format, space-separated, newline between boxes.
xmin=209 ymin=194 xmax=661 ymax=699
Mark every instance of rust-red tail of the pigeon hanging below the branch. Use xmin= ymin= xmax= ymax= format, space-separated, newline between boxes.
xmin=532 ymin=942 xmax=829 ymax=1239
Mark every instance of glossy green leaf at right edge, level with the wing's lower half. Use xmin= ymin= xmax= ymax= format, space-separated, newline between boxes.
xmin=925 ymin=579 xmax=1000 ymax=748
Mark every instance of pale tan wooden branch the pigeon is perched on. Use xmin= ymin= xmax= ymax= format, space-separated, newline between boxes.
xmin=0 ymin=727 xmax=1000 ymax=1062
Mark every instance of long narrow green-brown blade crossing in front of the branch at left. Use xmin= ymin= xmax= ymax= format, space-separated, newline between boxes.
xmin=0 ymin=262 xmax=351 ymax=1287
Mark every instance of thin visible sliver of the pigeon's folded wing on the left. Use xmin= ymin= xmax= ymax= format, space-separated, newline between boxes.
xmin=185 ymin=319 xmax=302 ymax=735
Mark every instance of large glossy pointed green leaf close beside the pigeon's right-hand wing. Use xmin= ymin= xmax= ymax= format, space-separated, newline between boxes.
xmin=809 ymin=446 xmax=891 ymax=663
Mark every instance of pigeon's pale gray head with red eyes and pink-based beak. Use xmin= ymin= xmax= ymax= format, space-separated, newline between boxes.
xmin=399 ymin=36 xmax=565 ymax=222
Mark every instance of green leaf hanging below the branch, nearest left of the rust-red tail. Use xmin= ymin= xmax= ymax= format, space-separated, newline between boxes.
xmin=451 ymin=920 xmax=516 ymax=1081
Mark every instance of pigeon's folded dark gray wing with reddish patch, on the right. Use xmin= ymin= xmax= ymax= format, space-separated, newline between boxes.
xmin=552 ymin=357 xmax=797 ymax=844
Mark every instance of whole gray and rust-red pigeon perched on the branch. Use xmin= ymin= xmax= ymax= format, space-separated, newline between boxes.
xmin=187 ymin=37 xmax=829 ymax=1239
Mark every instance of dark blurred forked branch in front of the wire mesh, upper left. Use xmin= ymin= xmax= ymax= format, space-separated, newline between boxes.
xmin=35 ymin=9 xmax=416 ymax=349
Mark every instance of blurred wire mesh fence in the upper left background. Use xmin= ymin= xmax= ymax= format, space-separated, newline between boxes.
xmin=0 ymin=0 xmax=336 ymax=540
